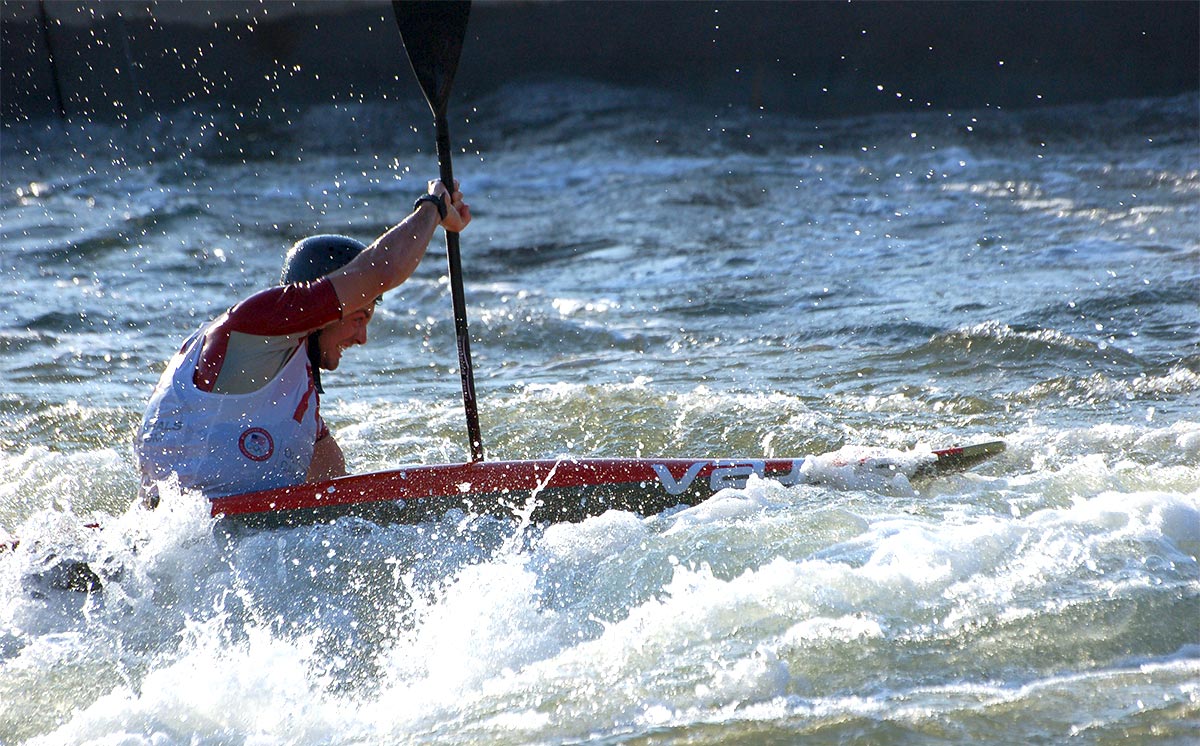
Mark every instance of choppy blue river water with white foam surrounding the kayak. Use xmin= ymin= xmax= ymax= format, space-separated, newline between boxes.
xmin=0 ymin=82 xmax=1200 ymax=745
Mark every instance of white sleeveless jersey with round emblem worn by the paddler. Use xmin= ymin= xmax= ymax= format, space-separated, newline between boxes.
xmin=134 ymin=329 xmax=319 ymax=499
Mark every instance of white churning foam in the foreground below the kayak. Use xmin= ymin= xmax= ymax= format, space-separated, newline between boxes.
xmin=7 ymin=427 xmax=1200 ymax=744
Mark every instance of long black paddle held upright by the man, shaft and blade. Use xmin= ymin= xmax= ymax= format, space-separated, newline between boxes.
xmin=391 ymin=0 xmax=484 ymax=462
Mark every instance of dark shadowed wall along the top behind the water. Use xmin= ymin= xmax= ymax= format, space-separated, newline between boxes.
xmin=7 ymin=0 xmax=1200 ymax=124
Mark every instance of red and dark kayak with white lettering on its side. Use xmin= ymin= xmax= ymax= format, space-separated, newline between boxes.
xmin=212 ymin=441 xmax=1004 ymax=525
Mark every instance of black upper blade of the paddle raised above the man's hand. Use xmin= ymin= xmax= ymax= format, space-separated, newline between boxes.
xmin=391 ymin=0 xmax=470 ymax=116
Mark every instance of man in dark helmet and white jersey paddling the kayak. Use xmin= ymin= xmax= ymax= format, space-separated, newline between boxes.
xmin=134 ymin=181 xmax=470 ymax=507
